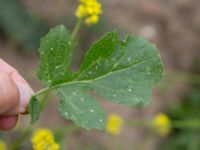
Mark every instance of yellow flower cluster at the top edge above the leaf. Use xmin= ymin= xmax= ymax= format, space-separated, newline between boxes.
xmin=75 ymin=0 xmax=102 ymax=25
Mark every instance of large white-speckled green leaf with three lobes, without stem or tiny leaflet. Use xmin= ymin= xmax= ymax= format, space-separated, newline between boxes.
xmin=30 ymin=25 xmax=163 ymax=129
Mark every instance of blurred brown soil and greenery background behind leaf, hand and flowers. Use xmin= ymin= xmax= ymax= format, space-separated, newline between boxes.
xmin=0 ymin=0 xmax=200 ymax=150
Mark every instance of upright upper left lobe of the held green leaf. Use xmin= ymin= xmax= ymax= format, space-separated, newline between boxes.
xmin=38 ymin=25 xmax=72 ymax=86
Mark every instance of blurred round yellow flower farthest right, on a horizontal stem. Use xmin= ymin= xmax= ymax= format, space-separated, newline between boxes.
xmin=153 ymin=113 xmax=171 ymax=136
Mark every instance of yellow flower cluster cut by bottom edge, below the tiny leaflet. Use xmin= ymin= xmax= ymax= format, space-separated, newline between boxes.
xmin=31 ymin=129 xmax=60 ymax=150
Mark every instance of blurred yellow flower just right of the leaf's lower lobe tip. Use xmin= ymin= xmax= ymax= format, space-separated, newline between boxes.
xmin=106 ymin=114 xmax=124 ymax=135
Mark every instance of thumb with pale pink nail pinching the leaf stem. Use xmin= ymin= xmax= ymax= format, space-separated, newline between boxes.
xmin=0 ymin=73 xmax=32 ymax=116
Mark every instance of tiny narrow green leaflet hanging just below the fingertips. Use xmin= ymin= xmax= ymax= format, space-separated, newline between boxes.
xmin=28 ymin=97 xmax=41 ymax=124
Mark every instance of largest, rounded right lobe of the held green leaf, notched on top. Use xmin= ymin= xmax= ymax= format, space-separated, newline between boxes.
xmin=76 ymin=32 xmax=163 ymax=106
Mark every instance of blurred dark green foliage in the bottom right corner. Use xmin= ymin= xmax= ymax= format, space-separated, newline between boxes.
xmin=158 ymin=60 xmax=200 ymax=150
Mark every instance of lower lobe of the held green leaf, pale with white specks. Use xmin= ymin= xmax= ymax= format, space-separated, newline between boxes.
xmin=56 ymin=83 xmax=106 ymax=129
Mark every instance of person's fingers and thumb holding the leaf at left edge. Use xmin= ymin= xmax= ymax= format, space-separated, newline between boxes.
xmin=0 ymin=59 xmax=33 ymax=130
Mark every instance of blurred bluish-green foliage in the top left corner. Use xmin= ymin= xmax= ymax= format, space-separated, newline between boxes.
xmin=0 ymin=0 xmax=48 ymax=51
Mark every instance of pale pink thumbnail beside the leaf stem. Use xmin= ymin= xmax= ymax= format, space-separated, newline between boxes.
xmin=15 ymin=81 xmax=33 ymax=113
